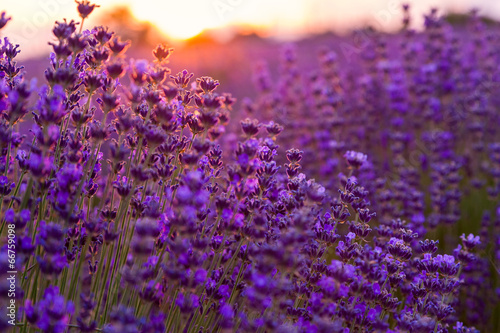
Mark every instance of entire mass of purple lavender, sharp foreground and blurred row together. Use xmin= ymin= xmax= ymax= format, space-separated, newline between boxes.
xmin=0 ymin=1 xmax=500 ymax=333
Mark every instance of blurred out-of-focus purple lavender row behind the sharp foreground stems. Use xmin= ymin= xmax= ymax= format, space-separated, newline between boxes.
xmin=246 ymin=6 xmax=500 ymax=331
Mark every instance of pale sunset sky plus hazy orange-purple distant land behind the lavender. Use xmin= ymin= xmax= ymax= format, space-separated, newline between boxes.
xmin=0 ymin=0 xmax=500 ymax=98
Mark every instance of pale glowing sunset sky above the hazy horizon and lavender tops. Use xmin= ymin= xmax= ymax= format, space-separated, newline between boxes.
xmin=0 ymin=0 xmax=500 ymax=58
